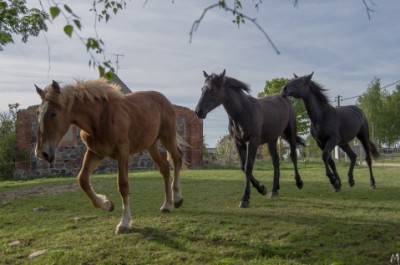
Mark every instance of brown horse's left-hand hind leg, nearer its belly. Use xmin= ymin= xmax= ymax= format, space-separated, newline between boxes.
xmin=147 ymin=141 xmax=172 ymax=213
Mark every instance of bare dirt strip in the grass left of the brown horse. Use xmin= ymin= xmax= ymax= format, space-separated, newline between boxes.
xmin=0 ymin=183 xmax=80 ymax=203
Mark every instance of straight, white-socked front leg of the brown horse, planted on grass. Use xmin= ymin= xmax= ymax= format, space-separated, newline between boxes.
xmin=115 ymin=154 xmax=132 ymax=234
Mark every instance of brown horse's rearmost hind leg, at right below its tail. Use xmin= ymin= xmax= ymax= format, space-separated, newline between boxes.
xmin=163 ymin=137 xmax=183 ymax=208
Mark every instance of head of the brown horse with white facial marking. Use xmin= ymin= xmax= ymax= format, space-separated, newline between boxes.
xmin=35 ymin=81 xmax=70 ymax=163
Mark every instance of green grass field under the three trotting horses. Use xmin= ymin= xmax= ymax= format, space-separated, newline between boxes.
xmin=0 ymin=162 xmax=400 ymax=264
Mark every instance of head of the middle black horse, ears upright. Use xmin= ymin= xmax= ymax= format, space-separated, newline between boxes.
xmin=195 ymin=70 xmax=225 ymax=119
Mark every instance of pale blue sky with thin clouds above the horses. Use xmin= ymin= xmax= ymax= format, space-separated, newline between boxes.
xmin=0 ymin=0 xmax=400 ymax=147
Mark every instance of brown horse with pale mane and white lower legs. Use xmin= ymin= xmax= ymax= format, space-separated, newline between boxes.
xmin=35 ymin=79 xmax=183 ymax=233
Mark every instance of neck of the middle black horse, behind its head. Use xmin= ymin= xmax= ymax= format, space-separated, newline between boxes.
xmin=222 ymin=89 xmax=251 ymax=124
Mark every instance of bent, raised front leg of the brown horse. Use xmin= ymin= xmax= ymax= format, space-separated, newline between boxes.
xmin=77 ymin=150 xmax=114 ymax=211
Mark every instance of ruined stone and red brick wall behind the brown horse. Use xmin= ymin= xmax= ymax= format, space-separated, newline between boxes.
xmin=14 ymin=105 xmax=203 ymax=179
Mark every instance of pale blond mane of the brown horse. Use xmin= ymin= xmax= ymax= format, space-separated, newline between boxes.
xmin=44 ymin=78 xmax=124 ymax=105
